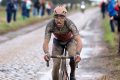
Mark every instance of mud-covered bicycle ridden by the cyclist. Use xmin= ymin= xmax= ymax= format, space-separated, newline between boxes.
xmin=47 ymin=47 xmax=74 ymax=80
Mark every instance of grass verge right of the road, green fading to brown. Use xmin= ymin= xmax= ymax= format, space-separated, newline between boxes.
xmin=103 ymin=17 xmax=120 ymax=80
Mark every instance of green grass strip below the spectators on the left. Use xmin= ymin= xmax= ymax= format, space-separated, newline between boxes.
xmin=0 ymin=16 xmax=50 ymax=34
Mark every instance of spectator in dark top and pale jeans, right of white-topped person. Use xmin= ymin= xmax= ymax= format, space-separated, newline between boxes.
xmin=33 ymin=0 xmax=40 ymax=16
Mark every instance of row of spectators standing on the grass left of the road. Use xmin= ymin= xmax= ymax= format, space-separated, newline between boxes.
xmin=6 ymin=0 xmax=53 ymax=23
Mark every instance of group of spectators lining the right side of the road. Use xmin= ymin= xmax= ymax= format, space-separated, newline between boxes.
xmin=101 ymin=0 xmax=120 ymax=53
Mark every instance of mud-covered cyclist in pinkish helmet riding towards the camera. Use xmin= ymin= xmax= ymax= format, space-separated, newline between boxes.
xmin=43 ymin=6 xmax=82 ymax=80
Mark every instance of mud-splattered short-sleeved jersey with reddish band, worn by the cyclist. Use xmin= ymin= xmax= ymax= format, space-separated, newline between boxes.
xmin=45 ymin=18 xmax=79 ymax=42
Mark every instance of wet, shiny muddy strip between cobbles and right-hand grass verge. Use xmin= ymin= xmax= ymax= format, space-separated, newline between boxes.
xmin=77 ymin=12 xmax=110 ymax=80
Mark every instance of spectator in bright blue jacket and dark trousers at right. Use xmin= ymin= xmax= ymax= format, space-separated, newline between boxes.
xmin=108 ymin=0 xmax=116 ymax=32
